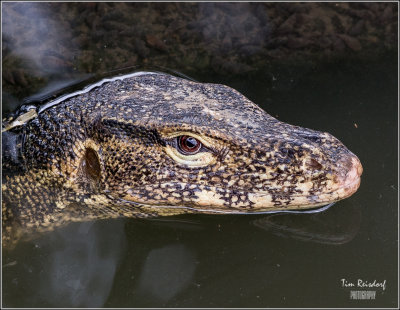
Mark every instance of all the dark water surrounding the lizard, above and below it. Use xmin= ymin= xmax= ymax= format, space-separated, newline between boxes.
xmin=2 ymin=3 xmax=398 ymax=308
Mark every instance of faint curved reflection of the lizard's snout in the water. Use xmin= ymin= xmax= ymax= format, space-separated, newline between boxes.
xmin=253 ymin=205 xmax=361 ymax=245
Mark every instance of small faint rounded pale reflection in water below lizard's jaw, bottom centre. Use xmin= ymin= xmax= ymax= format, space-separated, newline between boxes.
xmin=138 ymin=244 xmax=196 ymax=303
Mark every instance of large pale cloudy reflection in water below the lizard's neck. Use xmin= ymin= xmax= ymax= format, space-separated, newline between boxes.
xmin=3 ymin=221 xmax=124 ymax=307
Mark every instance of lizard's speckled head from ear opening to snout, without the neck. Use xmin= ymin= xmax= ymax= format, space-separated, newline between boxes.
xmin=76 ymin=74 xmax=362 ymax=215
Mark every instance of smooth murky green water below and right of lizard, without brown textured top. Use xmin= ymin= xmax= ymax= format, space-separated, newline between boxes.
xmin=2 ymin=1 xmax=398 ymax=307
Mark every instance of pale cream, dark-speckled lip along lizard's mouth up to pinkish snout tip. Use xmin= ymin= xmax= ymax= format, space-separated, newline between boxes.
xmin=119 ymin=156 xmax=363 ymax=214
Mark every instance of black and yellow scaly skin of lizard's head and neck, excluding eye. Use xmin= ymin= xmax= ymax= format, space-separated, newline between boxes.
xmin=2 ymin=73 xmax=362 ymax=243
